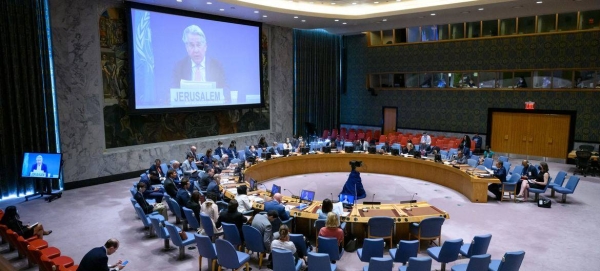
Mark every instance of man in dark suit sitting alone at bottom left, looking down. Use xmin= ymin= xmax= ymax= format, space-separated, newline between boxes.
xmin=77 ymin=238 xmax=125 ymax=271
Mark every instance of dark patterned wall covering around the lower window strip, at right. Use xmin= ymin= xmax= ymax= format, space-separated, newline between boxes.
xmin=340 ymin=31 xmax=600 ymax=142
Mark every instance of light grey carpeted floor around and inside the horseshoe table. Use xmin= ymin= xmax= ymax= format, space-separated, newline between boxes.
xmin=0 ymin=160 xmax=600 ymax=271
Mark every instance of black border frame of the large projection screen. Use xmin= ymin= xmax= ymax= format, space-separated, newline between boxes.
xmin=125 ymin=1 xmax=266 ymax=115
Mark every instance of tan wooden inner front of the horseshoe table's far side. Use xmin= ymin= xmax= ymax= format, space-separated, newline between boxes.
xmin=244 ymin=153 xmax=500 ymax=203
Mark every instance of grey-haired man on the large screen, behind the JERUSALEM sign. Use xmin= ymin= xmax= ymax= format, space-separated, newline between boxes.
xmin=172 ymin=25 xmax=230 ymax=101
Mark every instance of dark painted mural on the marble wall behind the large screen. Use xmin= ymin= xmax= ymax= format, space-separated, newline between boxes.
xmin=99 ymin=8 xmax=270 ymax=149
